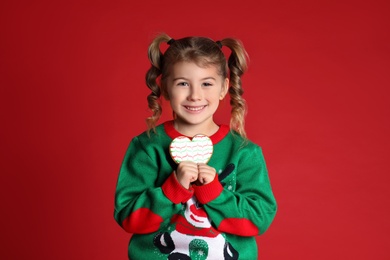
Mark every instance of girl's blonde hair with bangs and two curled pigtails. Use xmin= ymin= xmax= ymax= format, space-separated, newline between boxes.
xmin=145 ymin=33 xmax=248 ymax=137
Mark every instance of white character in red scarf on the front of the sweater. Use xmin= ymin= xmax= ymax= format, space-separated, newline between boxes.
xmin=153 ymin=197 xmax=238 ymax=260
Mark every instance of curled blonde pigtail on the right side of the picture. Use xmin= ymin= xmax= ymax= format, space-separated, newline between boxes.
xmin=220 ymin=38 xmax=248 ymax=137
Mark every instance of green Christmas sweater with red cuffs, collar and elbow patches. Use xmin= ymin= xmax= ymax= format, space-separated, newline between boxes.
xmin=114 ymin=121 xmax=277 ymax=260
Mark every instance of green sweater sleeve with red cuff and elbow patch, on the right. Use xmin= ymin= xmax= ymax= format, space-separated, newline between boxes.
xmin=195 ymin=145 xmax=277 ymax=236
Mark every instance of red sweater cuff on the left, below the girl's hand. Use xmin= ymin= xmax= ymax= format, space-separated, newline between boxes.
xmin=161 ymin=173 xmax=194 ymax=204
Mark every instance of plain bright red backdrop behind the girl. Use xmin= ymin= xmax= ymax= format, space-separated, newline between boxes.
xmin=0 ymin=0 xmax=390 ymax=260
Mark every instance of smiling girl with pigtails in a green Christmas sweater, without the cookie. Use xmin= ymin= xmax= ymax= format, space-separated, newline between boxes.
xmin=114 ymin=34 xmax=277 ymax=260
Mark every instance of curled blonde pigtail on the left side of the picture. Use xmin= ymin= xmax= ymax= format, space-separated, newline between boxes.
xmin=145 ymin=34 xmax=171 ymax=132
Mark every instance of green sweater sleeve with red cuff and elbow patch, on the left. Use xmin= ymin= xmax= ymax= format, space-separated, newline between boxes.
xmin=114 ymin=137 xmax=193 ymax=234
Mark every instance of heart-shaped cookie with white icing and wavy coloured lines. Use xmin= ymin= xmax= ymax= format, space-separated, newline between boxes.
xmin=169 ymin=134 xmax=213 ymax=163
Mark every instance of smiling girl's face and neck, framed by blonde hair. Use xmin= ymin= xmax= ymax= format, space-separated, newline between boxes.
xmin=167 ymin=62 xmax=229 ymax=135
